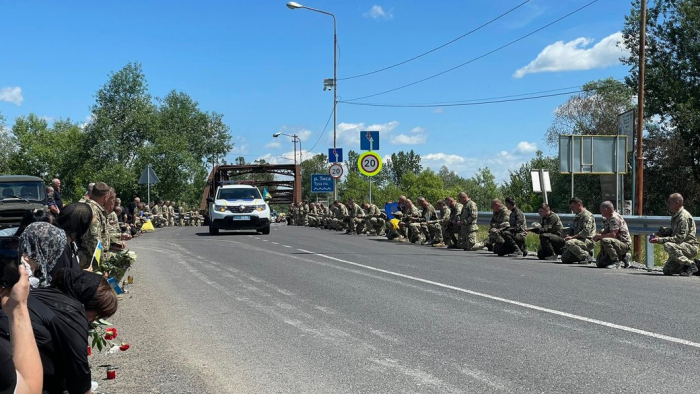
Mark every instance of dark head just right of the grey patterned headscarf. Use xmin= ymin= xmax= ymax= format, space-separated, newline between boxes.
xmin=55 ymin=202 xmax=92 ymax=268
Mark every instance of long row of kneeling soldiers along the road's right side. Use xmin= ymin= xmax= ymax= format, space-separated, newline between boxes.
xmin=287 ymin=192 xmax=700 ymax=276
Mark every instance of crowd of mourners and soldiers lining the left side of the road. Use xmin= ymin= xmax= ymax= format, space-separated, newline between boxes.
xmin=0 ymin=179 xmax=203 ymax=394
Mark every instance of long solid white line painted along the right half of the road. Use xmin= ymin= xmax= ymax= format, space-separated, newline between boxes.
xmin=297 ymin=249 xmax=700 ymax=348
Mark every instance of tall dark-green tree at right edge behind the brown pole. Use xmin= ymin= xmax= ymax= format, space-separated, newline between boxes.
xmin=622 ymin=0 xmax=700 ymax=182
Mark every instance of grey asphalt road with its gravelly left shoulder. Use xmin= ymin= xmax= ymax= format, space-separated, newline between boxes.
xmin=101 ymin=226 xmax=700 ymax=393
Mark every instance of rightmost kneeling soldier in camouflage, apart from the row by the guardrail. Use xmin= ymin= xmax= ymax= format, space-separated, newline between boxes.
xmin=649 ymin=193 xmax=698 ymax=276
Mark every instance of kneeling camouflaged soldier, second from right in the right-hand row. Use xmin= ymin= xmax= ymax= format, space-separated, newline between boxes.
xmin=593 ymin=201 xmax=632 ymax=268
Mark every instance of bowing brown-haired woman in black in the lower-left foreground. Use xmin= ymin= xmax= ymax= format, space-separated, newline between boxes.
xmin=0 ymin=269 xmax=118 ymax=394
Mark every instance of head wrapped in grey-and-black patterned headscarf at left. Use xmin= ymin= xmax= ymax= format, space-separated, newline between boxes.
xmin=19 ymin=222 xmax=68 ymax=288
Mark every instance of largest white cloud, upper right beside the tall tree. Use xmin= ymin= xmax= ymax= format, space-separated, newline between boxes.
xmin=513 ymin=32 xmax=628 ymax=78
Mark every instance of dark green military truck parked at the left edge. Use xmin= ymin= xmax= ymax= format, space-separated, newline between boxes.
xmin=0 ymin=175 xmax=47 ymax=230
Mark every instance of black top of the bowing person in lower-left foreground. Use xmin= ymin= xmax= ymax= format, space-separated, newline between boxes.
xmin=0 ymin=288 xmax=92 ymax=394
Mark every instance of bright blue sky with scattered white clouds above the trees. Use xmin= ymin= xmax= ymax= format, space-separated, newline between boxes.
xmin=0 ymin=0 xmax=630 ymax=180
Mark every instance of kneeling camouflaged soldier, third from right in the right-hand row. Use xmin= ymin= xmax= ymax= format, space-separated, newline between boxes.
xmin=561 ymin=197 xmax=596 ymax=264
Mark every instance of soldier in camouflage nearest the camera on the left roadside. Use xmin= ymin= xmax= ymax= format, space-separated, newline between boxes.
xmin=78 ymin=182 xmax=110 ymax=269
